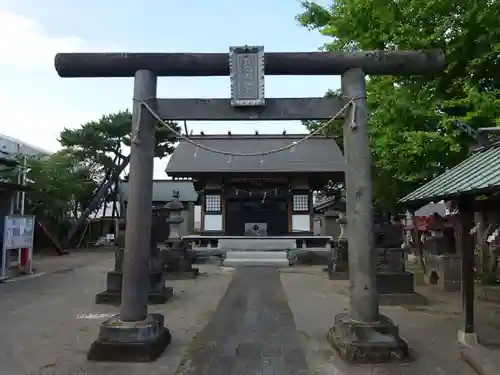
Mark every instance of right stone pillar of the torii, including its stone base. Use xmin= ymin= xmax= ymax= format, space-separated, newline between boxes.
xmin=327 ymin=68 xmax=408 ymax=363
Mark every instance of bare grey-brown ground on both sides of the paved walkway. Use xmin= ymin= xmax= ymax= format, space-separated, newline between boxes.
xmin=0 ymin=251 xmax=500 ymax=375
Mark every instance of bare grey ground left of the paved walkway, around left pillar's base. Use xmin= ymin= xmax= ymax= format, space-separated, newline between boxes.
xmin=0 ymin=252 xmax=232 ymax=375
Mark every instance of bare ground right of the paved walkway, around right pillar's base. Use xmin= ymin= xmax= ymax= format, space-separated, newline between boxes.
xmin=281 ymin=267 xmax=500 ymax=375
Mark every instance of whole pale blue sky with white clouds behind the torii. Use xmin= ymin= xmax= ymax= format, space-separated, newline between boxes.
xmin=0 ymin=0 xmax=340 ymax=178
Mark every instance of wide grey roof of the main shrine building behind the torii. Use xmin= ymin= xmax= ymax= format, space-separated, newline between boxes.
xmin=165 ymin=134 xmax=345 ymax=176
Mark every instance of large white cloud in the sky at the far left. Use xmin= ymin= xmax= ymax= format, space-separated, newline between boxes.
xmin=0 ymin=10 xmax=107 ymax=151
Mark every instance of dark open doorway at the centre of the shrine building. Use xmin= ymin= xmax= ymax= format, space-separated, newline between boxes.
xmin=226 ymin=196 xmax=288 ymax=236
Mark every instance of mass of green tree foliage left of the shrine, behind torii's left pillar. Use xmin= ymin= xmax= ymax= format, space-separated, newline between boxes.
xmin=5 ymin=111 xmax=180 ymax=244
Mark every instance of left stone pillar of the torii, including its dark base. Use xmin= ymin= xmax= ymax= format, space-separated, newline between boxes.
xmin=87 ymin=70 xmax=171 ymax=362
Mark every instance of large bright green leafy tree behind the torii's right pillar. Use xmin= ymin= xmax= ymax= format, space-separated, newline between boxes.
xmin=297 ymin=0 xmax=500 ymax=211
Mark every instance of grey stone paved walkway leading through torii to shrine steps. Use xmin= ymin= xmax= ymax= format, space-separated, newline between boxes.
xmin=176 ymin=267 xmax=309 ymax=375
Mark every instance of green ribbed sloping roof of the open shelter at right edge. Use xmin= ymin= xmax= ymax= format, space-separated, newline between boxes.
xmin=399 ymin=142 xmax=500 ymax=205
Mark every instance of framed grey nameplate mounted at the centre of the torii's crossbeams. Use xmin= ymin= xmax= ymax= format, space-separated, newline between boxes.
xmin=229 ymin=46 xmax=266 ymax=107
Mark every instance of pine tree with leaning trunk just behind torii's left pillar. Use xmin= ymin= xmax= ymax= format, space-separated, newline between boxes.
xmin=59 ymin=111 xmax=180 ymax=240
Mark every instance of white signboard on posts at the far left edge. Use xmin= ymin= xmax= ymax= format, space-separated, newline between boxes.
xmin=3 ymin=215 xmax=35 ymax=250
